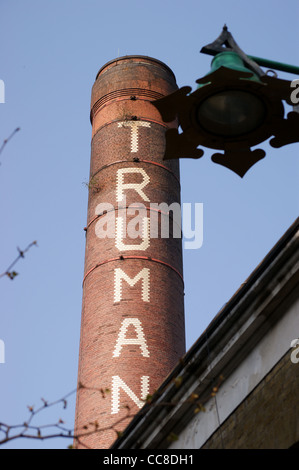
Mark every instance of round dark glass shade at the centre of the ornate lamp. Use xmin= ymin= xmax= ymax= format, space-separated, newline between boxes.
xmin=196 ymin=90 xmax=266 ymax=138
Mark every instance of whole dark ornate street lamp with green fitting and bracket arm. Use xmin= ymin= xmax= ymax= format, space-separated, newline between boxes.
xmin=152 ymin=26 xmax=299 ymax=177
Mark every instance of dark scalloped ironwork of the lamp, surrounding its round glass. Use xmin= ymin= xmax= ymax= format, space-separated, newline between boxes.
xmin=152 ymin=29 xmax=299 ymax=177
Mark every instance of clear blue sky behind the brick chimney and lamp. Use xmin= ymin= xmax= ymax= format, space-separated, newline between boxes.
xmin=0 ymin=0 xmax=299 ymax=448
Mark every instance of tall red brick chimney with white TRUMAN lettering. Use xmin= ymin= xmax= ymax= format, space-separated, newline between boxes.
xmin=75 ymin=56 xmax=185 ymax=449
